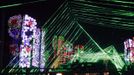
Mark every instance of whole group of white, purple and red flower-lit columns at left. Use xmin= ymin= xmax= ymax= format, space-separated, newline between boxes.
xmin=8 ymin=15 xmax=45 ymax=71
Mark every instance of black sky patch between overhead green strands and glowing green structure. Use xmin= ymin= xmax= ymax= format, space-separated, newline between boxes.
xmin=80 ymin=22 xmax=134 ymax=53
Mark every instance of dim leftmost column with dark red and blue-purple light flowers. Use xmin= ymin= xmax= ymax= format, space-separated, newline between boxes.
xmin=8 ymin=15 xmax=22 ymax=65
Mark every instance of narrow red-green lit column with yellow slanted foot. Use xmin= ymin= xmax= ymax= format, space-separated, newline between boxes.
xmin=51 ymin=36 xmax=65 ymax=68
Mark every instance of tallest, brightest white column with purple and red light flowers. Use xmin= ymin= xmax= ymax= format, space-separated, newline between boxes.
xmin=19 ymin=15 xmax=37 ymax=68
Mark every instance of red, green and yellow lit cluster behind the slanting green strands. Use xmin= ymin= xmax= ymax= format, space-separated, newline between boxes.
xmin=51 ymin=36 xmax=74 ymax=68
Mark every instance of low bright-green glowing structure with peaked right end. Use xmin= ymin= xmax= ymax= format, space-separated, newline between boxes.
xmin=71 ymin=45 xmax=125 ymax=70
